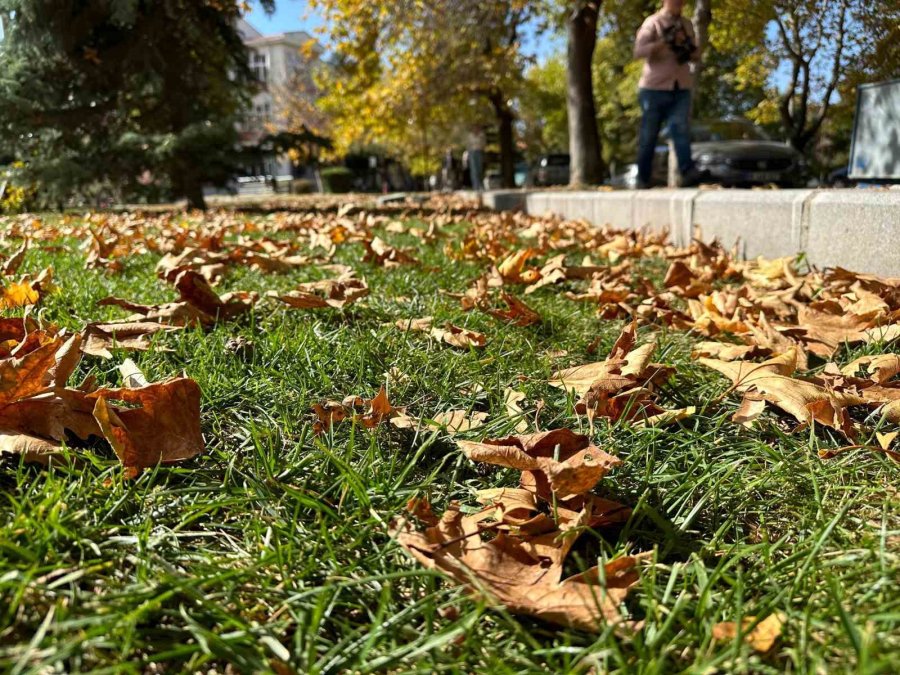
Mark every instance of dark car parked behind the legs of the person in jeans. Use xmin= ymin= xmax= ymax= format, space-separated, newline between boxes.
xmin=653 ymin=119 xmax=809 ymax=188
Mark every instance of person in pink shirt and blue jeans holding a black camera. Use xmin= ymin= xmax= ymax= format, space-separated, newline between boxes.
xmin=634 ymin=0 xmax=700 ymax=188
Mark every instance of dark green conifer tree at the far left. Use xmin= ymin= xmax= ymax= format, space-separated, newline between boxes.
xmin=0 ymin=0 xmax=271 ymax=209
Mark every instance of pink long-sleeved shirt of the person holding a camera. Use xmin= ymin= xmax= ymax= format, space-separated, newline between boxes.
xmin=634 ymin=10 xmax=699 ymax=91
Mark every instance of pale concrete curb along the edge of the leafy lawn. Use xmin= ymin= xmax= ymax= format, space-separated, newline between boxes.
xmin=472 ymin=189 xmax=900 ymax=276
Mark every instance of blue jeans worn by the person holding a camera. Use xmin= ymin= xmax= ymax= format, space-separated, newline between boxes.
xmin=638 ymin=89 xmax=694 ymax=186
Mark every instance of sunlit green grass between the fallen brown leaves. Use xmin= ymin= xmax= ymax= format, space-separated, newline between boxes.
xmin=0 ymin=209 xmax=900 ymax=673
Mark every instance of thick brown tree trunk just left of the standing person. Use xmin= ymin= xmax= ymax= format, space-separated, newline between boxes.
xmin=566 ymin=0 xmax=606 ymax=185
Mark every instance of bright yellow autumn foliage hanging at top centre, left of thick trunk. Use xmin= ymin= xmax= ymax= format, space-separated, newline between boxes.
xmin=311 ymin=0 xmax=534 ymax=173
